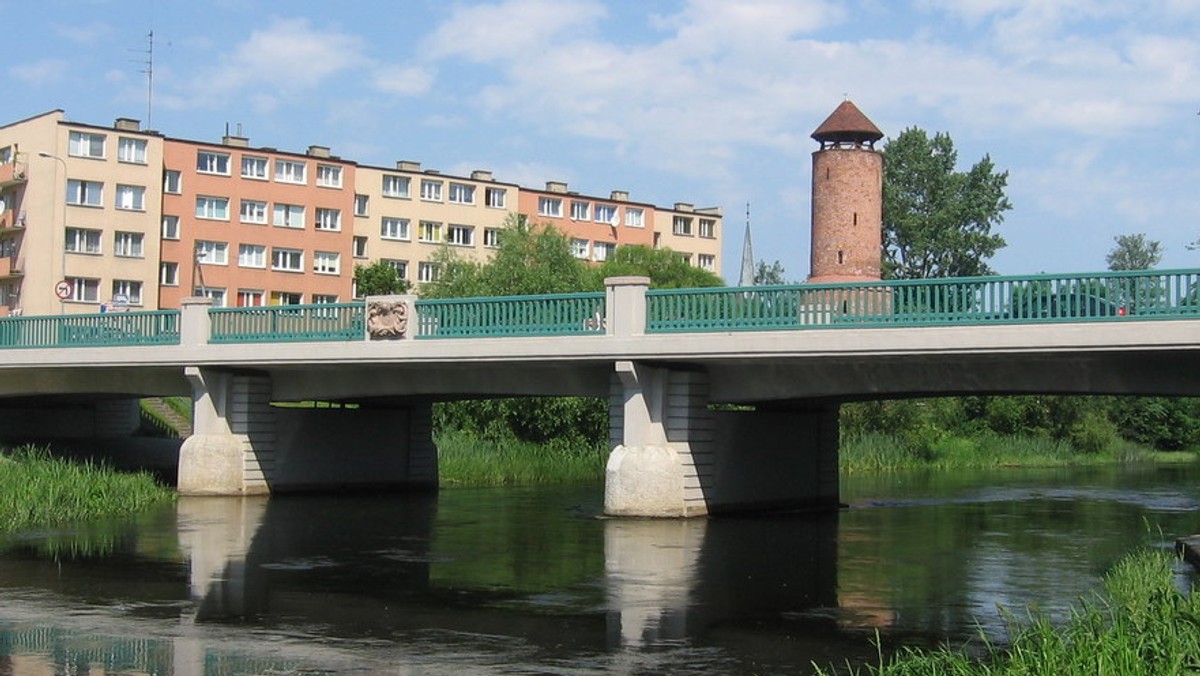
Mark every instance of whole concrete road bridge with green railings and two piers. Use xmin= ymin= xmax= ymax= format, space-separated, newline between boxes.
xmin=0 ymin=270 xmax=1200 ymax=516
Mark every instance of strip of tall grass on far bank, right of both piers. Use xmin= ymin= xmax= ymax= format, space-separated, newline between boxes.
xmin=838 ymin=433 xmax=1166 ymax=473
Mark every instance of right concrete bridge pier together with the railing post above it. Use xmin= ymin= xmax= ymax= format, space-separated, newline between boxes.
xmin=605 ymin=277 xmax=838 ymax=518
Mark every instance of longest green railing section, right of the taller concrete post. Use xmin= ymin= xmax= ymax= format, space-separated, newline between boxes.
xmin=646 ymin=270 xmax=1200 ymax=333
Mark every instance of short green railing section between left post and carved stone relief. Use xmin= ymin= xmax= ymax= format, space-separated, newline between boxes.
xmin=209 ymin=303 xmax=366 ymax=342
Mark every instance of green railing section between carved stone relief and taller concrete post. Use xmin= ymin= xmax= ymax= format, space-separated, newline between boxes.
xmin=416 ymin=292 xmax=605 ymax=339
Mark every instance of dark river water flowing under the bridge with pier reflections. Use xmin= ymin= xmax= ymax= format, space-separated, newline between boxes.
xmin=0 ymin=466 xmax=1200 ymax=675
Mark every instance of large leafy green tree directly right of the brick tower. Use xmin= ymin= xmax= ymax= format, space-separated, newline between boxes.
xmin=883 ymin=127 xmax=1012 ymax=279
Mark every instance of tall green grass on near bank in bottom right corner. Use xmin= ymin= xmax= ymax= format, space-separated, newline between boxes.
xmin=817 ymin=550 xmax=1200 ymax=676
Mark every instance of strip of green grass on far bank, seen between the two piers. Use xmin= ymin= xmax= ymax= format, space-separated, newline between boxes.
xmin=437 ymin=431 xmax=608 ymax=486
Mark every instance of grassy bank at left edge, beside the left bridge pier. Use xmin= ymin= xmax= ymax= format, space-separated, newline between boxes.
xmin=0 ymin=447 xmax=175 ymax=533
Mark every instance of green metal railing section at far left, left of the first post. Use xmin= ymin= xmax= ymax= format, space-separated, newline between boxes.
xmin=0 ymin=310 xmax=179 ymax=348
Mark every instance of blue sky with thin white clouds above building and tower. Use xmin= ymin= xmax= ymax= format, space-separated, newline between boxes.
xmin=0 ymin=0 xmax=1200 ymax=283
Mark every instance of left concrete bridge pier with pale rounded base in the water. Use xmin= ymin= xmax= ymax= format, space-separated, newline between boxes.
xmin=179 ymin=367 xmax=437 ymax=496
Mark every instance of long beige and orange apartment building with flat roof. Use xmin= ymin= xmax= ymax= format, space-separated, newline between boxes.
xmin=0 ymin=110 xmax=721 ymax=316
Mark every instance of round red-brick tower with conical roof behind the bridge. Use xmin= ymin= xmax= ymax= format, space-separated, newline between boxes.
xmin=809 ymin=101 xmax=883 ymax=283
